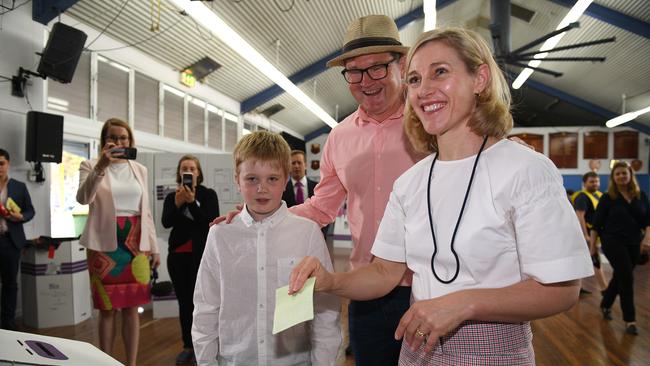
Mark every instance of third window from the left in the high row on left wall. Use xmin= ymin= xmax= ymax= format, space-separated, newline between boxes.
xmin=133 ymin=72 xmax=159 ymax=135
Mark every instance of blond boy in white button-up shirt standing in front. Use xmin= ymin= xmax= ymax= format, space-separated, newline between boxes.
xmin=192 ymin=131 xmax=341 ymax=366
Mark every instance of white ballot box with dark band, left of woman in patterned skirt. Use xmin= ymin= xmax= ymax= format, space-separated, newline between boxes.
xmin=20 ymin=240 xmax=91 ymax=328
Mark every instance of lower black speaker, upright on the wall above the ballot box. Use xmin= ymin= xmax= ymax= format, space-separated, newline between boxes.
xmin=25 ymin=111 xmax=63 ymax=163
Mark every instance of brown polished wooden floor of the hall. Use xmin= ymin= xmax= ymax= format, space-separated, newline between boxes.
xmin=21 ymin=249 xmax=650 ymax=366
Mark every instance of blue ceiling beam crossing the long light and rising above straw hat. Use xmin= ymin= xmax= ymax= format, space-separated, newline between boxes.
xmin=241 ymin=0 xmax=456 ymax=114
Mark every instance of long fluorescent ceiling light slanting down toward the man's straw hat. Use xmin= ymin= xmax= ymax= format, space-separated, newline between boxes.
xmin=171 ymin=0 xmax=338 ymax=128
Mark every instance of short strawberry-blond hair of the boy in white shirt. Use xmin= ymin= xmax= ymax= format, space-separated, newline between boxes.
xmin=232 ymin=131 xmax=291 ymax=177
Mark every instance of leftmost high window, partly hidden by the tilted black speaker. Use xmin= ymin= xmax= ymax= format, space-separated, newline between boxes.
xmin=47 ymin=53 xmax=90 ymax=118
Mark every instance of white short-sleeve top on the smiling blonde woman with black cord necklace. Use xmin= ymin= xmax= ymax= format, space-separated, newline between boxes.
xmin=372 ymin=140 xmax=593 ymax=301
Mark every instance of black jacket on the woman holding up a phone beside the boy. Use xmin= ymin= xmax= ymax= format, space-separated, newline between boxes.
xmin=162 ymin=185 xmax=219 ymax=264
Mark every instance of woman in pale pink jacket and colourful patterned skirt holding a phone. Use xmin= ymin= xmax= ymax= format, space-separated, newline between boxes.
xmin=77 ymin=118 xmax=160 ymax=366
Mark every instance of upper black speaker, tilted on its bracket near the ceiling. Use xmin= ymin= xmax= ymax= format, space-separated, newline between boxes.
xmin=38 ymin=22 xmax=88 ymax=84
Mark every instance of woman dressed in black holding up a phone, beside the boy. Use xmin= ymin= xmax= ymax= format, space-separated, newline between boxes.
xmin=162 ymin=155 xmax=219 ymax=365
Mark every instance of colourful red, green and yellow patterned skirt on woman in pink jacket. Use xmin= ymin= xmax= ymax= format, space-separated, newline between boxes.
xmin=88 ymin=216 xmax=151 ymax=310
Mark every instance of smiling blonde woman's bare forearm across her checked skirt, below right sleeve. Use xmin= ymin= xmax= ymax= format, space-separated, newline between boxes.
xmin=452 ymin=279 xmax=580 ymax=323
